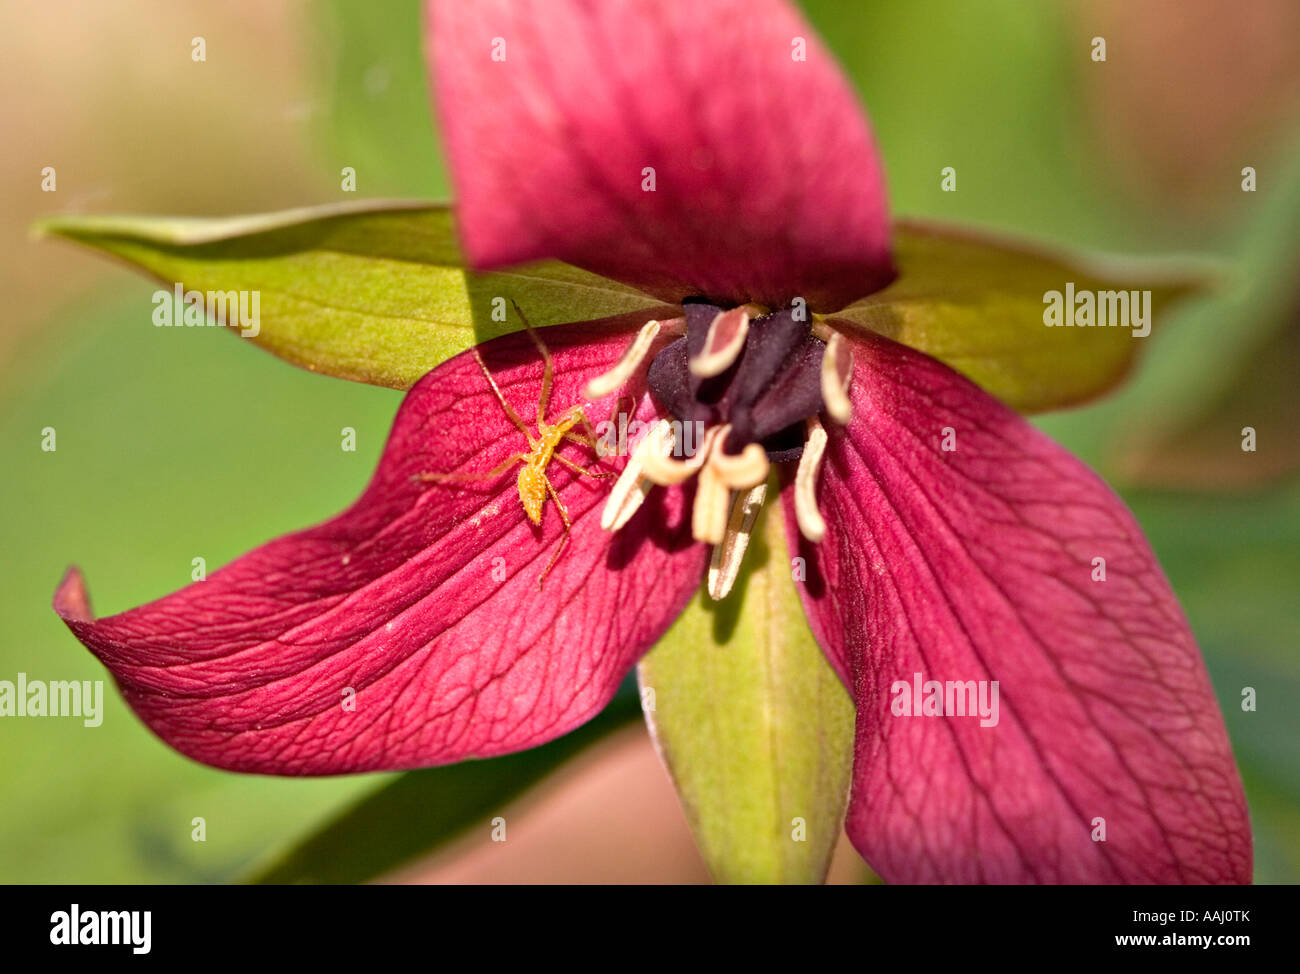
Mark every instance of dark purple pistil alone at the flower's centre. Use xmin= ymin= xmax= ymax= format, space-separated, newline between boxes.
xmin=649 ymin=302 xmax=826 ymax=462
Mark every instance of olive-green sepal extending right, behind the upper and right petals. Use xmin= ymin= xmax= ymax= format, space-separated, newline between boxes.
xmin=829 ymin=222 xmax=1209 ymax=412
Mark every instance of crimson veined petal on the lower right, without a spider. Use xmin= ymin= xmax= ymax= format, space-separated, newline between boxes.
xmin=789 ymin=330 xmax=1251 ymax=883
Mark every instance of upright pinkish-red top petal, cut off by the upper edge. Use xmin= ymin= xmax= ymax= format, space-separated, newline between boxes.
xmin=429 ymin=0 xmax=893 ymax=311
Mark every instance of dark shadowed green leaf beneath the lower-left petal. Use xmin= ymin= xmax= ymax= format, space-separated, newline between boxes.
xmin=250 ymin=694 xmax=637 ymax=884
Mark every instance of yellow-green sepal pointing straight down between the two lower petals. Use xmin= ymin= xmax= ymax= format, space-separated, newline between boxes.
xmin=640 ymin=490 xmax=854 ymax=883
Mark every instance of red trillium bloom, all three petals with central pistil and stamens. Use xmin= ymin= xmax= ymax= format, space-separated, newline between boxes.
xmin=55 ymin=0 xmax=1251 ymax=883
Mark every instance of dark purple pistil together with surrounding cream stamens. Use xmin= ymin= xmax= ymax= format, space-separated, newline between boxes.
xmin=585 ymin=300 xmax=852 ymax=598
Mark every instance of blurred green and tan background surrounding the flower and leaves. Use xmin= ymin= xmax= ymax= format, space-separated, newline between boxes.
xmin=0 ymin=0 xmax=1300 ymax=883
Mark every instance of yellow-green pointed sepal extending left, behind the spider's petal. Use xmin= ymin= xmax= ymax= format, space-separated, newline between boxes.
xmin=36 ymin=202 xmax=659 ymax=389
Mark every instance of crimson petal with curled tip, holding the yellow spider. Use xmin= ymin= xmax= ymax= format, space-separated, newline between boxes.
xmin=55 ymin=324 xmax=706 ymax=774
